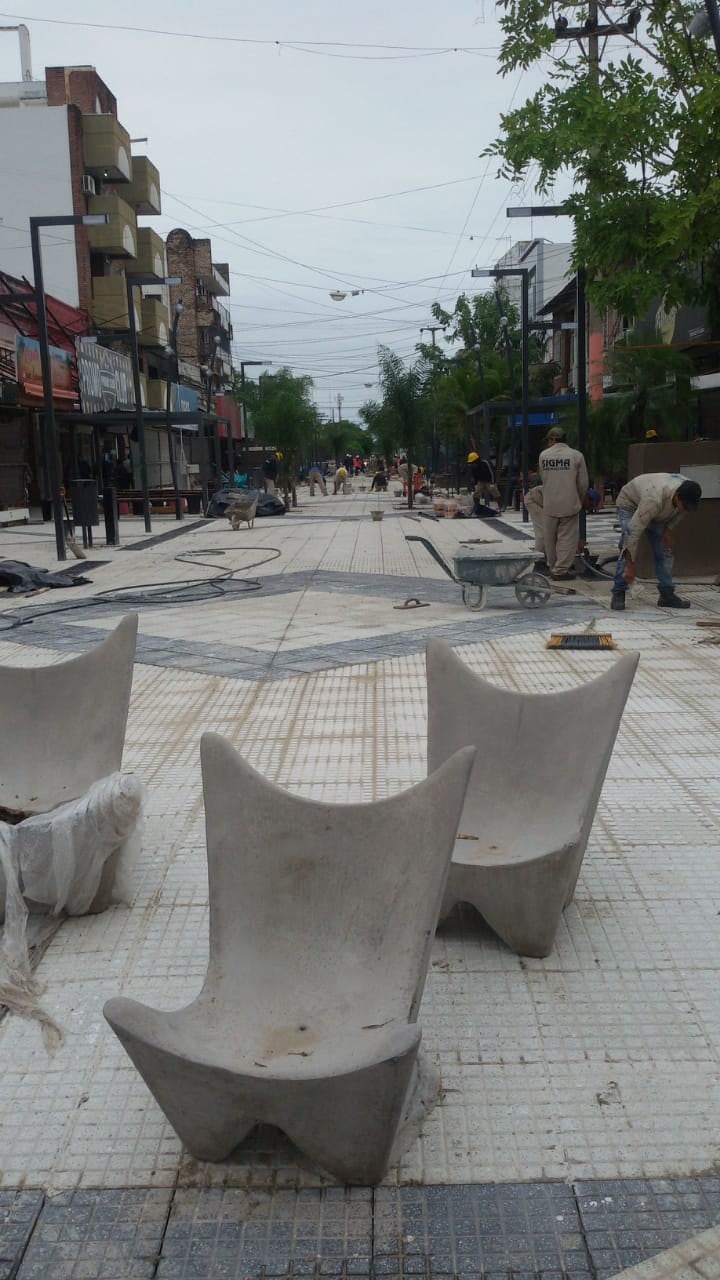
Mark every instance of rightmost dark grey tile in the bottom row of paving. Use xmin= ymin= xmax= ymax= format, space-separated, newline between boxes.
xmin=575 ymin=1178 xmax=720 ymax=1280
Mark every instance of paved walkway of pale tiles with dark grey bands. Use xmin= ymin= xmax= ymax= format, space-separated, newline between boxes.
xmin=0 ymin=483 xmax=720 ymax=1280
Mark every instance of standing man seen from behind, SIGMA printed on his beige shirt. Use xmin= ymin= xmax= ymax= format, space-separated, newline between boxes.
xmin=538 ymin=426 xmax=588 ymax=582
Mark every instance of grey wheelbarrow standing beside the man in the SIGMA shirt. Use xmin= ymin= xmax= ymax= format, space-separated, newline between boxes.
xmin=406 ymin=535 xmax=550 ymax=609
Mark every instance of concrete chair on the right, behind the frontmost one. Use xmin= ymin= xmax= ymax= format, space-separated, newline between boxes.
xmin=427 ymin=640 xmax=639 ymax=956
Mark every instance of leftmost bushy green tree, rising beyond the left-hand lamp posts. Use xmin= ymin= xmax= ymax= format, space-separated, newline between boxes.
xmin=233 ymin=369 xmax=318 ymax=507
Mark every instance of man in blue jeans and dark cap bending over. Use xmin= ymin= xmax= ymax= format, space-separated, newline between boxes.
xmin=611 ymin=471 xmax=702 ymax=609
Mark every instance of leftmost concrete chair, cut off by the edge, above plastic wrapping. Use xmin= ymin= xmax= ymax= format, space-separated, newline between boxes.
xmin=0 ymin=613 xmax=137 ymax=911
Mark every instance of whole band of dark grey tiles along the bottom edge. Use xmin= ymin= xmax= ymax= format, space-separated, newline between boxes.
xmin=0 ymin=1176 xmax=720 ymax=1280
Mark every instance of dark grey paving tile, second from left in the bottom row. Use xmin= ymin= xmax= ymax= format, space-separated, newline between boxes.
xmin=17 ymin=1189 xmax=173 ymax=1280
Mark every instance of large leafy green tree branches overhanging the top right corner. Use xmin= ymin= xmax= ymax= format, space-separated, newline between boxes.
xmin=488 ymin=0 xmax=720 ymax=321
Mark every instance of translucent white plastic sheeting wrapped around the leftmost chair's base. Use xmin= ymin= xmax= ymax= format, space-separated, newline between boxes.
xmin=0 ymin=773 xmax=145 ymax=1052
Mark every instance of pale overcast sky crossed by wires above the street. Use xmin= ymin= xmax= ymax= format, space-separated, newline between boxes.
xmin=0 ymin=0 xmax=569 ymax=419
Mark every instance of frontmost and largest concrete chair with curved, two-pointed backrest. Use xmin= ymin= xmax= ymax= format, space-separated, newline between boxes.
xmin=105 ymin=733 xmax=474 ymax=1184
